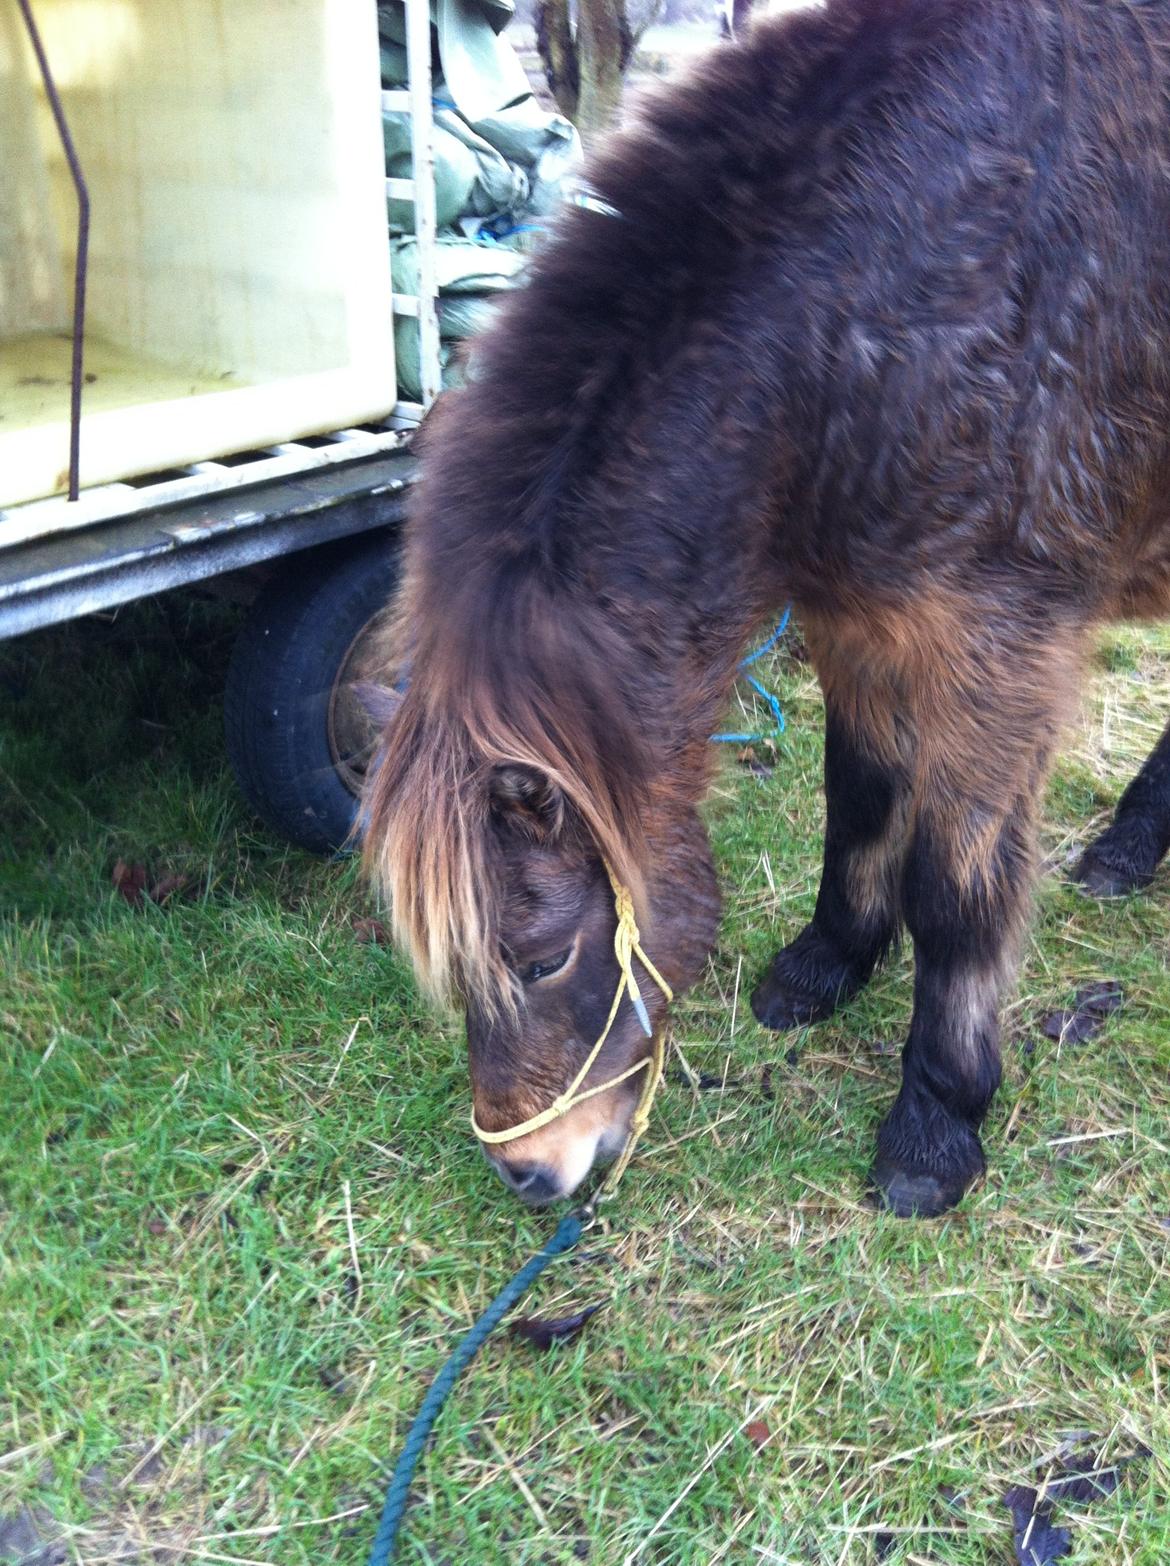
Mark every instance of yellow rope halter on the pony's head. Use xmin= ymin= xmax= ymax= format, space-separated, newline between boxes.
xmin=471 ymin=864 xmax=673 ymax=1190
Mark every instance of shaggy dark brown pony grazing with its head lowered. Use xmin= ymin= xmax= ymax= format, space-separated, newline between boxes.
xmin=365 ymin=0 xmax=1170 ymax=1214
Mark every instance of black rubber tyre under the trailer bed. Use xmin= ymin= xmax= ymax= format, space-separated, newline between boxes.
xmin=224 ymin=532 xmax=398 ymax=853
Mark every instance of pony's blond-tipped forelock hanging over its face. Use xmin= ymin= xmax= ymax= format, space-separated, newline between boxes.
xmin=363 ymin=557 xmax=648 ymax=1013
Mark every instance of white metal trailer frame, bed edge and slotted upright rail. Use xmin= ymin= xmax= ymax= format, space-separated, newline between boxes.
xmin=0 ymin=0 xmax=442 ymax=639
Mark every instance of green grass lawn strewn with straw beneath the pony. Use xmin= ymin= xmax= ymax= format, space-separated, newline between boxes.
xmin=0 ymin=597 xmax=1170 ymax=1566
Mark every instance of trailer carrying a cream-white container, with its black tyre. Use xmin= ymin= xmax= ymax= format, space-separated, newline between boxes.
xmin=0 ymin=0 xmax=469 ymax=852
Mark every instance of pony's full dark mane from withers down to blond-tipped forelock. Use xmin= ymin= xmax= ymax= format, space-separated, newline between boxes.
xmin=363 ymin=0 xmax=983 ymax=1009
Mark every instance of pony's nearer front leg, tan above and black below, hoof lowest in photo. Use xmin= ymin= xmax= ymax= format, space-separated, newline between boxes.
xmin=872 ymin=628 xmax=1078 ymax=1217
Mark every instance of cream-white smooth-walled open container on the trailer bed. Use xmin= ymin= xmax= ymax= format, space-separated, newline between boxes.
xmin=0 ymin=0 xmax=396 ymax=516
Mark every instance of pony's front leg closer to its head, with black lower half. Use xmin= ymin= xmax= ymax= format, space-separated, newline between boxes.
xmin=752 ymin=622 xmax=910 ymax=1029
